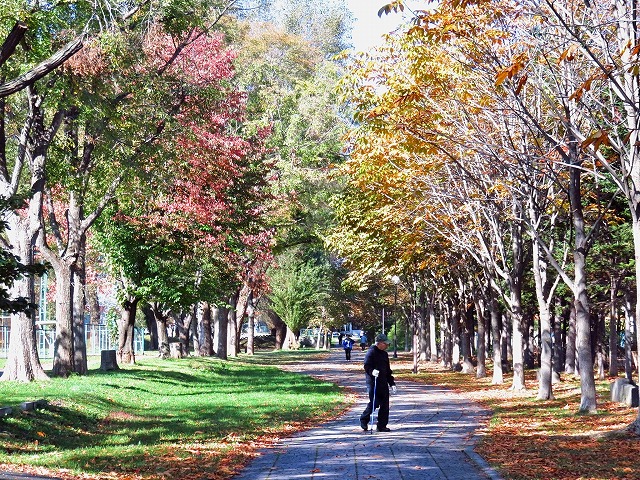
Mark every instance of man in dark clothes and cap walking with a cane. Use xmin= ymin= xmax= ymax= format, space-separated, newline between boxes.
xmin=360 ymin=333 xmax=396 ymax=432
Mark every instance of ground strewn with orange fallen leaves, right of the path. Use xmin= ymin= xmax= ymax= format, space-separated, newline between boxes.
xmin=392 ymin=357 xmax=640 ymax=480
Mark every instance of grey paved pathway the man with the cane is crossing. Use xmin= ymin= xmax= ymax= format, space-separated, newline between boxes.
xmin=234 ymin=349 xmax=500 ymax=480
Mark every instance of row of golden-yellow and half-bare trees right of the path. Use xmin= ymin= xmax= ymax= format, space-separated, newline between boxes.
xmin=329 ymin=1 xmax=640 ymax=428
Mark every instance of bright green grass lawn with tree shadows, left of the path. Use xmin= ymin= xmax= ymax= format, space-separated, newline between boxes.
xmin=0 ymin=350 xmax=346 ymax=480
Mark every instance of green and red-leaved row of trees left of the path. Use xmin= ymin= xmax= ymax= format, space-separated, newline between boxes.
xmin=0 ymin=0 xmax=356 ymax=381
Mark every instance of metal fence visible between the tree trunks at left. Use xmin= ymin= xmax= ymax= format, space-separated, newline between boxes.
xmin=0 ymin=325 xmax=144 ymax=358
